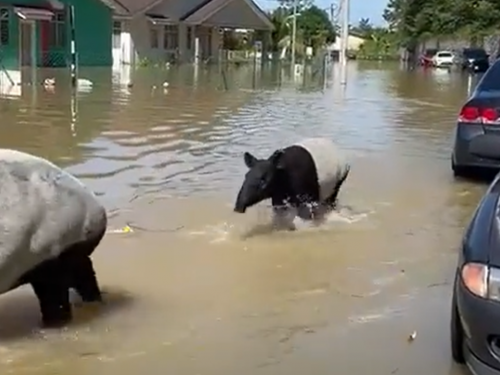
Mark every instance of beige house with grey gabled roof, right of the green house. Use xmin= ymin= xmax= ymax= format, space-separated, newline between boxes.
xmin=109 ymin=0 xmax=273 ymax=65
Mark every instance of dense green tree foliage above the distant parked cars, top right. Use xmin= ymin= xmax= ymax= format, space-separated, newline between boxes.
xmin=384 ymin=0 xmax=500 ymax=47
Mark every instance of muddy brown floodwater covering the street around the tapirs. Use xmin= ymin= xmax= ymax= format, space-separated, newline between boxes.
xmin=0 ymin=63 xmax=486 ymax=375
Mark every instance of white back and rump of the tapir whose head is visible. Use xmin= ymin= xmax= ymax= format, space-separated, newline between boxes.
xmin=296 ymin=138 xmax=349 ymax=200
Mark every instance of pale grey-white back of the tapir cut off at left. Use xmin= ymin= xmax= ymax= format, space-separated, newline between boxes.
xmin=0 ymin=149 xmax=106 ymax=293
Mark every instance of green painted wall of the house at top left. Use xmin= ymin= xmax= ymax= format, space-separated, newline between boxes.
xmin=0 ymin=0 xmax=113 ymax=69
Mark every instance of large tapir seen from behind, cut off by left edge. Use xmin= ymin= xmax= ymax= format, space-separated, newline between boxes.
xmin=0 ymin=149 xmax=107 ymax=326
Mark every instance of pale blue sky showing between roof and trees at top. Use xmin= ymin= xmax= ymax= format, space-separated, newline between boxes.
xmin=255 ymin=0 xmax=387 ymax=25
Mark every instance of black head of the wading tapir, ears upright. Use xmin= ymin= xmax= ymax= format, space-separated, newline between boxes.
xmin=234 ymin=150 xmax=283 ymax=213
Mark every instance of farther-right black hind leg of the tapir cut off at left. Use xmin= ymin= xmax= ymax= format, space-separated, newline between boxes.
xmin=60 ymin=231 xmax=105 ymax=302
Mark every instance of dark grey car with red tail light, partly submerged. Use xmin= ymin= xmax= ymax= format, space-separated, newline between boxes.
xmin=451 ymin=60 xmax=500 ymax=176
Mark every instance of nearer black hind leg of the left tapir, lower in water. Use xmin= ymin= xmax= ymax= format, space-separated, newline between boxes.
xmin=25 ymin=259 xmax=72 ymax=327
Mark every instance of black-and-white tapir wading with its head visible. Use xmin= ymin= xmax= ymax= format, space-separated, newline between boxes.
xmin=234 ymin=138 xmax=350 ymax=228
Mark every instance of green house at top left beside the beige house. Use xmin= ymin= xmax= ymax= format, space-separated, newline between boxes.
xmin=0 ymin=0 xmax=113 ymax=73
